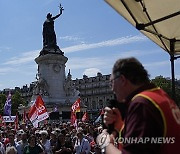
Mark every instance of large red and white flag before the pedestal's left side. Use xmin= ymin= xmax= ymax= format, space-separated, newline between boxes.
xmin=28 ymin=95 xmax=49 ymax=127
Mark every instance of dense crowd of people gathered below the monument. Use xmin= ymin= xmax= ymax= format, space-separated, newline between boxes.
xmin=0 ymin=122 xmax=102 ymax=154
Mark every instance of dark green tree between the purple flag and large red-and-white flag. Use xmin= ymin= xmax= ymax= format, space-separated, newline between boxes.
xmin=11 ymin=91 xmax=26 ymax=115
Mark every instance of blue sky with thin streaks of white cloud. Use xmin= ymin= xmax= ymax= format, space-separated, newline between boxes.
xmin=0 ymin=0 xmax=180 ymax=90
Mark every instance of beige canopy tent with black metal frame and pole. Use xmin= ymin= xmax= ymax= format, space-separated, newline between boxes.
xmin=105 ymin=0 xmax=180 ymax=98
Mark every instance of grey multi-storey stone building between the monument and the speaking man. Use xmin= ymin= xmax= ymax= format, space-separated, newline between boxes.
xmin=73 ymin=73 xmax=114 ymax=119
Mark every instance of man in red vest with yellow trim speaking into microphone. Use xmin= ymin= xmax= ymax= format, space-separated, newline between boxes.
xmin=97 ymin=57 xmax=180 ymax=154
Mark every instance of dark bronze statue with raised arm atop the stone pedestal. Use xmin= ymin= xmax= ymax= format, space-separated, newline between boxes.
xmin=40 ymin=4 xmax=64 ymax=55
